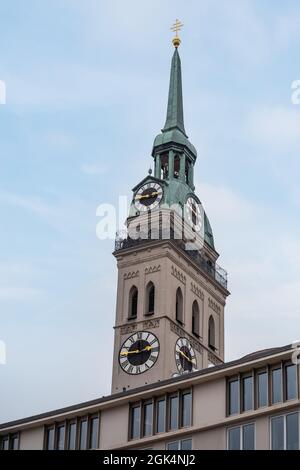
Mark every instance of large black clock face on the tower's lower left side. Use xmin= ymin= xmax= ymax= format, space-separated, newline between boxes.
xmin=119 ymin=331 xmax=159 ymax=375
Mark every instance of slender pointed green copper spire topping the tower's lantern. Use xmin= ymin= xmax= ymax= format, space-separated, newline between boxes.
xmin=163 ymin=47 xmax=186 ymax=135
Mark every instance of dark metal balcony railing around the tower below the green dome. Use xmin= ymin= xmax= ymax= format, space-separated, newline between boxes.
xmin=115 ymin=235 xmax=228 ymax=289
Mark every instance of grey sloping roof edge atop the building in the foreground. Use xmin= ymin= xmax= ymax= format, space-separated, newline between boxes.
xmin=0 ymin=344 xmax=293 ymax=432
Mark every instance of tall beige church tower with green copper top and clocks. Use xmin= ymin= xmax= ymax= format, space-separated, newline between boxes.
xmin=112 ymin=23 xmax=229 ymax=393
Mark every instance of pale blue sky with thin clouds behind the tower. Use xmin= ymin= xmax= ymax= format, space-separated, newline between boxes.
xmin=0 ymin=0 xmax=300 ymax=422
